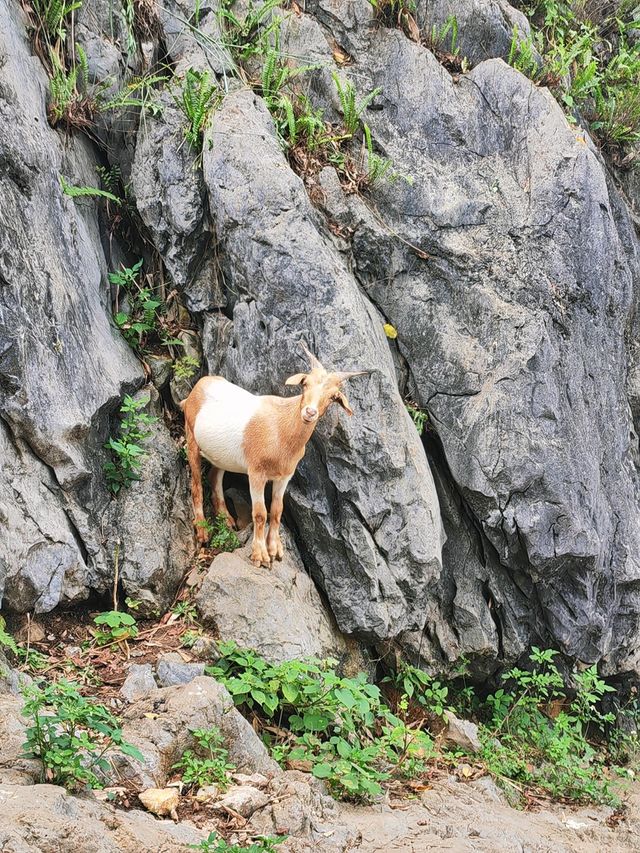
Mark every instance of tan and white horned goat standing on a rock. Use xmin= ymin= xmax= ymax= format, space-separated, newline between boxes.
xmin=180 ymin=344 xmax=369 ymax=567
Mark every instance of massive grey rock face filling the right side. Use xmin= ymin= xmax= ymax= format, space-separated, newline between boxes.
xmin=270 ymin=15 xmax=640 ymax=673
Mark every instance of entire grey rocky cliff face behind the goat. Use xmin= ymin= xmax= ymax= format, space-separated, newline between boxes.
xmin=0 ymin=0 xmax=640 ymax=674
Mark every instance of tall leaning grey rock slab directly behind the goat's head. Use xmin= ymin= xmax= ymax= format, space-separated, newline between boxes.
xmin=203 ymin=91 xmax=442 ymax=641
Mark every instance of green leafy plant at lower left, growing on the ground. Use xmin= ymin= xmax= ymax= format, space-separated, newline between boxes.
xmin=22 ymin=679 xmax=143 ymax=790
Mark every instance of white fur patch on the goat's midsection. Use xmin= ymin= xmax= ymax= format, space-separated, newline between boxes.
xmin=193 ymin=379 xmax=260 ymax=474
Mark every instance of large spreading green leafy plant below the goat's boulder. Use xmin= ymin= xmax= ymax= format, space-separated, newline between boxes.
xmin=207 ymin=643 xmax=431 ymax=800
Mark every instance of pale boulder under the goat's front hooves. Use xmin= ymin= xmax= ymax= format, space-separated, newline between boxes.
xmin=196 ymin=531 xmax=364 ymax=668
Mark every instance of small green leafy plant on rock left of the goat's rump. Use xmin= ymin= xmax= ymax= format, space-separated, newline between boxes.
xmin=103 ymin=394 xmax=157 ymax=495
